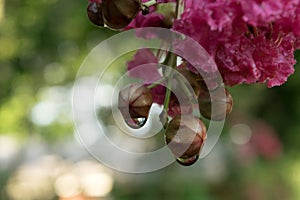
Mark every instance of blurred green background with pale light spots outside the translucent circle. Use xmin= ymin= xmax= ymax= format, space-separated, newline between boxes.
xmin=0 ymin=0 xmax=300 ymax=200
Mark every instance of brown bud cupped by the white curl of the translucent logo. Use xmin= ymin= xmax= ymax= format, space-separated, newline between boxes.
xmin=118 ymin=83 xmax=153 ymax=128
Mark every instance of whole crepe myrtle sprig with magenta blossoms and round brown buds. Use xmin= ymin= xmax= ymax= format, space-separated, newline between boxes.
xmin=87 ymin=0 xmax=300 ymax=166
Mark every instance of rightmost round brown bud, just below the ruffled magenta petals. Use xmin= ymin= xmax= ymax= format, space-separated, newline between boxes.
xmin=198 ymin=87 xmax=233 ymax=121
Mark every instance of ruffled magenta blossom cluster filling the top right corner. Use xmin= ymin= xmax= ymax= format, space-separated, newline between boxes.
xmin=128 ymin=0 xmax=300 ymax=87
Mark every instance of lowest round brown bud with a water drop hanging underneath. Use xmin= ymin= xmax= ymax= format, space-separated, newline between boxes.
xmin=165 ymin=115 xmax=206 ymax=166
